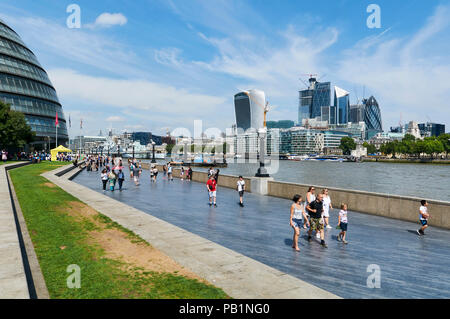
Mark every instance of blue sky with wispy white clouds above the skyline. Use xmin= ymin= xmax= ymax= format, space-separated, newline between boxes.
xmin=0 ymin=0 xmax=450 ymax=137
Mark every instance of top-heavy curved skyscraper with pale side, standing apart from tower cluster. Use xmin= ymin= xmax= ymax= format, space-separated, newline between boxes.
xmin=234 ymin=90 xmax=266 ymax=131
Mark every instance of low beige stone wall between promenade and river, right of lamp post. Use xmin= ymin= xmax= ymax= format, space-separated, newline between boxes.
xmin=268 ymin=181 xmax=450 ymax=229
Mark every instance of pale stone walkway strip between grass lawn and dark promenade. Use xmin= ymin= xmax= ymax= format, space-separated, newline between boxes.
xmin=43 ymin=167 xmax=339 ymax=299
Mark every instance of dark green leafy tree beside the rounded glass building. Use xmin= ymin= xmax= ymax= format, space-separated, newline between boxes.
xmin=0 ymin=101 xmax=35 ymax=148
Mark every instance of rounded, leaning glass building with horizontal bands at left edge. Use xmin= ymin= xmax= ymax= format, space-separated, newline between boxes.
xmin=0 ymin=19 xmax=69 ymax=149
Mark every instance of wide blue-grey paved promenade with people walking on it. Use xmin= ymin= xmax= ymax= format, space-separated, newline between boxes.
xmin=74 ymin=171 xmax=450 ymax=298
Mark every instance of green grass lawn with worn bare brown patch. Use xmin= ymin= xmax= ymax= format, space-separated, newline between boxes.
xmin=10 ymin=162 xmax=228 ymax=299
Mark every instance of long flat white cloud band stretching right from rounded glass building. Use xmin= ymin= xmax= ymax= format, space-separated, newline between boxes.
xmin=49 ymin=69 xmax=225 ymax=115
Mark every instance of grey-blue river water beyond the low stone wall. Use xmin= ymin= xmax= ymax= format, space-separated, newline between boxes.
xmin=149 ymin=161 xmax=450 ymax=201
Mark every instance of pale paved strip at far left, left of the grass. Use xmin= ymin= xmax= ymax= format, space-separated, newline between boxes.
xmin=0 ymin=163 xmax=30 ymax=299
